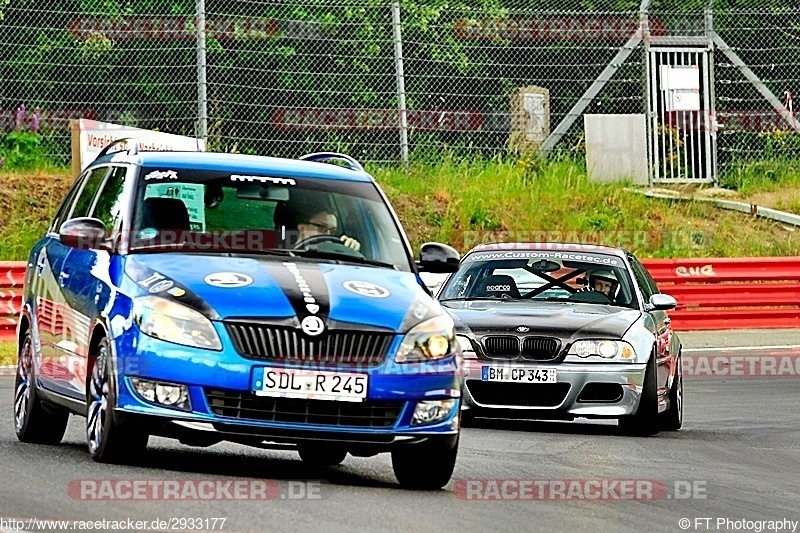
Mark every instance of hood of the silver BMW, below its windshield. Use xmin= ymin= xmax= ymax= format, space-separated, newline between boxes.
xmin=444 ymin=301 xmax=641 ymax=340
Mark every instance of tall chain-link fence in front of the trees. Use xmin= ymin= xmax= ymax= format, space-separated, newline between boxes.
xmin=0 ymin=0 xmax=800 ymax=172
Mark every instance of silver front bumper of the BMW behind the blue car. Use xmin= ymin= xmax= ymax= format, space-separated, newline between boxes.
xmin=462 ymin=360 xmax=647 ymax=420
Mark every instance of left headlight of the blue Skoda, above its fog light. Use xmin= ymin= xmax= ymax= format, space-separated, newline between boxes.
xmin=133 ymin=296 xmax=222 ymax=350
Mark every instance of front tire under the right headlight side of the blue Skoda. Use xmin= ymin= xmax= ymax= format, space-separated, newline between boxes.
xmin=392 ymin=441 xmax=458 ymax=490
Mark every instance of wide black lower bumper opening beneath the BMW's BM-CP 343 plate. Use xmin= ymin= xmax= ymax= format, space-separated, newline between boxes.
xmin=466 ymin=379 xmax=570 ymax=407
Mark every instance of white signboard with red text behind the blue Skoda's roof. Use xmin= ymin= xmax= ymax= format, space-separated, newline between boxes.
xmin=72 ymin=118 xmax=206 ymax=175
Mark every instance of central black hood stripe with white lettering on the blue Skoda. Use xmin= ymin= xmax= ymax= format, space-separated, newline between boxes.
xmin=261 ymin=261 xmax=331 ymax=320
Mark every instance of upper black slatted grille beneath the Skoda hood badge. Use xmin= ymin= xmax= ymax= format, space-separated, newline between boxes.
xmin=225 ymin=321 xmax=394 ymax=366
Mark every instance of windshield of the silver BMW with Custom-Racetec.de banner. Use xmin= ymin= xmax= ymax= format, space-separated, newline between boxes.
xmin=439 ymin=250 xmax=637 ymax=309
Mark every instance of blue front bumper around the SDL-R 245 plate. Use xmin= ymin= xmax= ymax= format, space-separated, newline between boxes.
xmin=114 ymin=328 xmax=462 ymax=454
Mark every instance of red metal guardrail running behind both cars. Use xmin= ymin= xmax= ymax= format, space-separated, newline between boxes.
xmin=0 ymin=257 xmax=800 ymax=340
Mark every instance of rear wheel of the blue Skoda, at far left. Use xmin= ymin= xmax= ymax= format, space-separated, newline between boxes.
xmin=14 ymin=332 xmax=69 ymax=444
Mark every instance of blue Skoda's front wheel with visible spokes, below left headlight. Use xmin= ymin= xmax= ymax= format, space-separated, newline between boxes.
xmin=86 ymin=339 xmax=148 ymax=464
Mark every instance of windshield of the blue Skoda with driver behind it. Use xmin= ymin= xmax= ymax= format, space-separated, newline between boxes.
xmin=130 ymin=168 xmax=411 ymax=271
